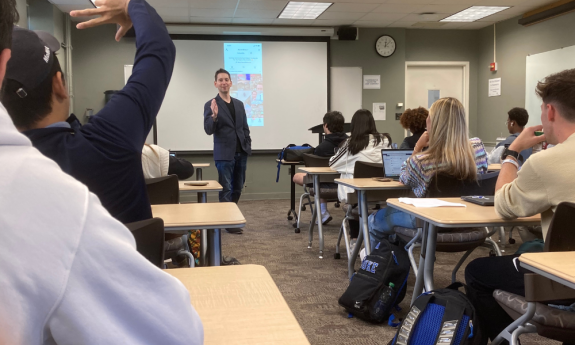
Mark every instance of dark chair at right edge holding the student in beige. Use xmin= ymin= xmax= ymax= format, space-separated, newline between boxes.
xmin=491 ymin=202 xmax=575 ymax=345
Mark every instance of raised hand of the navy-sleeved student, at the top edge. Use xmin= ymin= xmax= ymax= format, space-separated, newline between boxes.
xmin=70 ymin=0 xmax=132 ymax=41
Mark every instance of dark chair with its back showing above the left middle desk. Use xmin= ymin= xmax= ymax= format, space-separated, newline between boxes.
xmin=146 ymin=175 xmax=195 ymax=267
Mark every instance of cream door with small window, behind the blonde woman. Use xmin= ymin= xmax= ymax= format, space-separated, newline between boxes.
xmin=405 ymin=62 xmax=469 ymax=136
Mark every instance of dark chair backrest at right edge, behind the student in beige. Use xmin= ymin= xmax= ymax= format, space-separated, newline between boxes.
xmin=545 ymin=202 xmax=575 ymax=252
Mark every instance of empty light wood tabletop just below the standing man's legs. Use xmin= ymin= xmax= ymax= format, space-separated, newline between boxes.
xmin=152 ymin=202 xmax=246 ymax=231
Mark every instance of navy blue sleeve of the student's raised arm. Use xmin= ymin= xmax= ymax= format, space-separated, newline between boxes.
xmin=82 ymin=0 xmax=176 ymax=152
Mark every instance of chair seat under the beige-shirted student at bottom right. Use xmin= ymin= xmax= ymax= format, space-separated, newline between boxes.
xmin=493 ymin=290 xmax=575 ymax=330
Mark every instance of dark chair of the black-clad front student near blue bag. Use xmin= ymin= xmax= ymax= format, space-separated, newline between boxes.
xmin=293 ymin=153 xmax=339 ymax=234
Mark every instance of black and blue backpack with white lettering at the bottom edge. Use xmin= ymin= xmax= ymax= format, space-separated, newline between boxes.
xmin=389 ymin=283 xmax=482 ymax=345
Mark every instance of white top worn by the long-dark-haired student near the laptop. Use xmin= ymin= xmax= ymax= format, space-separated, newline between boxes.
xmin=329 ymin=134 xmax=391 ymax=203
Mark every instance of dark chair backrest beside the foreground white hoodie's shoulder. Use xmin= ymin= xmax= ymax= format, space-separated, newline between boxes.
xmin=125 ymin=218 xmax=164 ymax=268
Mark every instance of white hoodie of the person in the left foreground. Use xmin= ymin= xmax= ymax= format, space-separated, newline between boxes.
xmin=0 ymin=104 xmax=203 ymax=345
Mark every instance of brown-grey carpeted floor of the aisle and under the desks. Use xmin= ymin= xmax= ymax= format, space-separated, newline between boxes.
xmin=222 ymin=200 xmax=559 ymax=345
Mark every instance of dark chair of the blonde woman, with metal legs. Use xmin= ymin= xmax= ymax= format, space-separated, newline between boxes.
xmin=394 ymin=171 xmax=501 ymax=282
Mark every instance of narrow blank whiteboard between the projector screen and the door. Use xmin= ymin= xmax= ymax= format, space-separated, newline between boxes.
xmin=330 ymin=67 xmax=363 ymax=122
